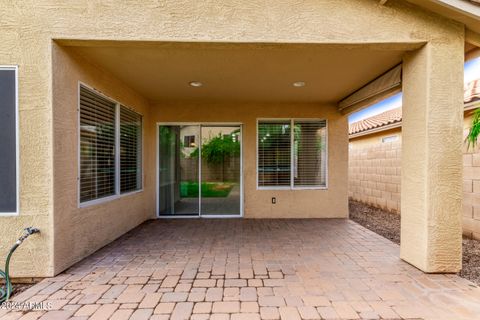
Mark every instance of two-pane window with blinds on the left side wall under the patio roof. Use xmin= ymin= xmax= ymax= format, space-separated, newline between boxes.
xmin=79 ymin=85 xmax=142 ymax=203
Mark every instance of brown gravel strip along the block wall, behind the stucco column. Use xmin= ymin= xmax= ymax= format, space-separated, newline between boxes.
xmin=349 ymin=200 xmax=480 ymax=285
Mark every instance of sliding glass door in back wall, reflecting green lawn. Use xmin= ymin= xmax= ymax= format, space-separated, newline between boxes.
xmin=158 ymin=124 xmax=242 ymax=217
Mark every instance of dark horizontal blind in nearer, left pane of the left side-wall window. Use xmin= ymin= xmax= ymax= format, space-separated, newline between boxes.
xmin=80 ymin=86 xmax=116 ymax=202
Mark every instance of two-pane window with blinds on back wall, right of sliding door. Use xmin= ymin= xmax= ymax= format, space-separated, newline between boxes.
xmin=257 ymin=120 xmax=327 ymax=188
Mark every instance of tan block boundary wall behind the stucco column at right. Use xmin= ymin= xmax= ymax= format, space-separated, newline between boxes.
xmin=348 ymin=111 xmax=480 ymax=239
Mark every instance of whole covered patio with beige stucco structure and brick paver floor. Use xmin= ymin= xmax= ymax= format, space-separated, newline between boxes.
xmin=0 ymin=0 xmax=480 ymax=320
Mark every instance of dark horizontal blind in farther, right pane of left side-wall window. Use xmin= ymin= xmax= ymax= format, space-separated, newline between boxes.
xmin=120 ymin=106 xmax=142 ymax=193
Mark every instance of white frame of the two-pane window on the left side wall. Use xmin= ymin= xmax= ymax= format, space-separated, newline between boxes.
xmin=77 ymin=81 xmax=145 ymax=208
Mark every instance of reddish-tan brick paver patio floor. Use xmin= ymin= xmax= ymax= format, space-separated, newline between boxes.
xmin=0 ymin=219 xmax=480 ymax=320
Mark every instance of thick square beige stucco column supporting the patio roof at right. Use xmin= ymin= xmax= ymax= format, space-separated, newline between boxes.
xmin=400 ymin=37 xmax=464 ymax=273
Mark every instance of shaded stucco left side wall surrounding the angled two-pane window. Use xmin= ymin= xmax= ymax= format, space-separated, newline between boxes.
xmin=52 ymin=45 xmax=155 ymax=276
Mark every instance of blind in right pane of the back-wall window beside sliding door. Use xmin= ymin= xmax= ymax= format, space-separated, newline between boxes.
xmin=293 ymin=120 xmax=326 ymax=187
